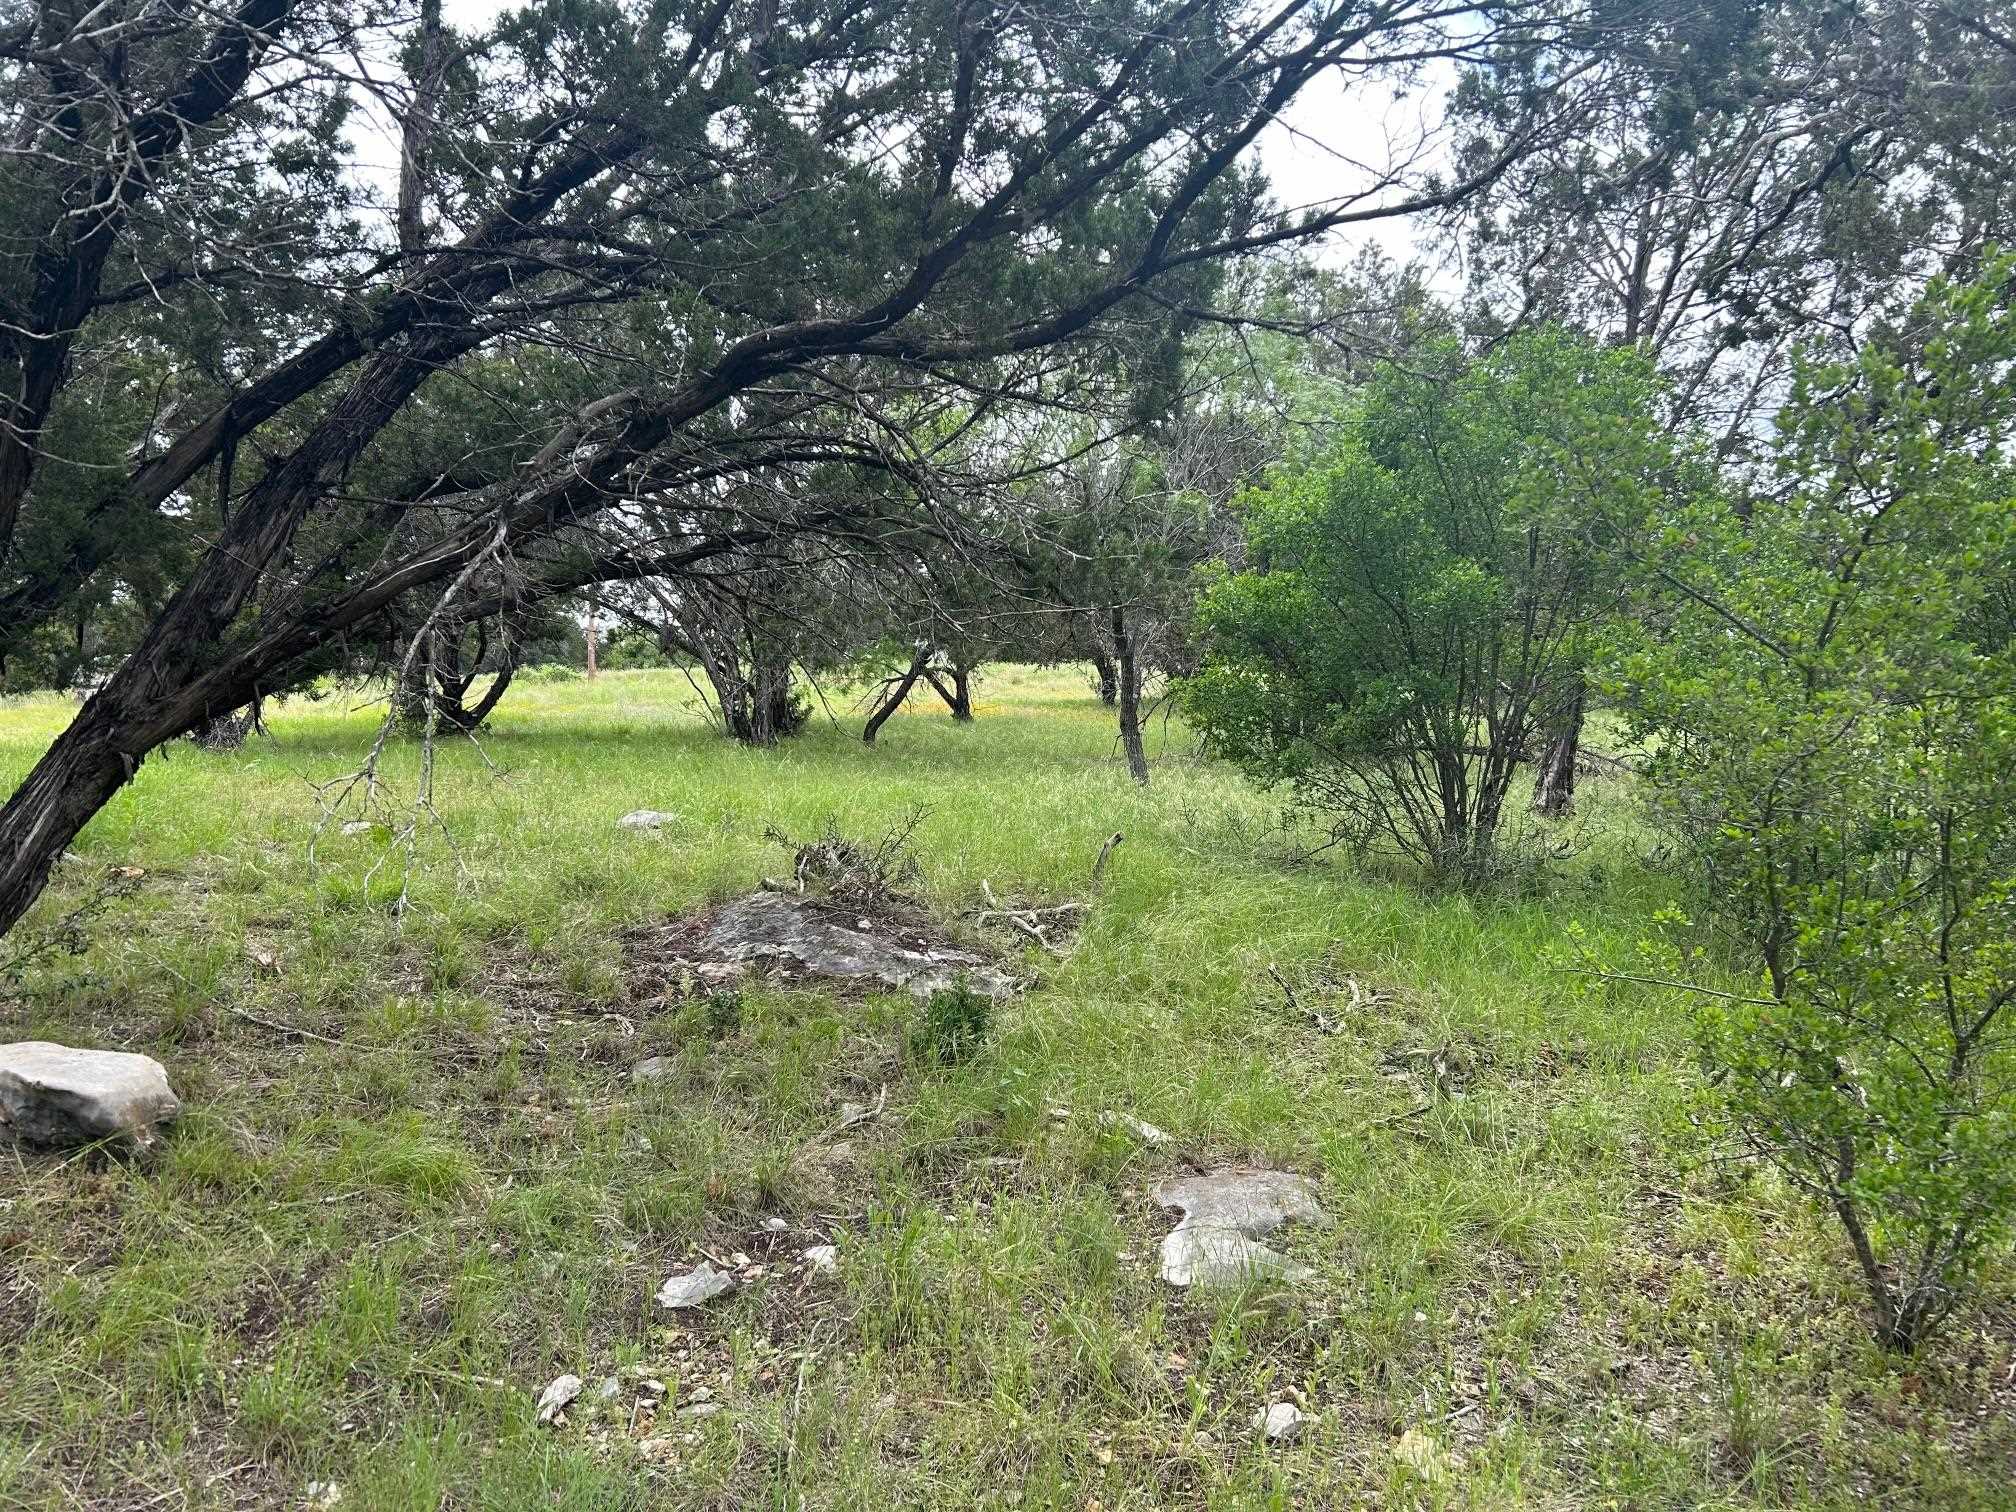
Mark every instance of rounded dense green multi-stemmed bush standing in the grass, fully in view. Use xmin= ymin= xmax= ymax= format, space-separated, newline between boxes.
xmin=1181 ymin=331 xmax=1669 ymax=879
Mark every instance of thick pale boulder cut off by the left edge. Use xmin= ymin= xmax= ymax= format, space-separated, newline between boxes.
xmin=0 ymin=1040 xmax=181 ymax=1145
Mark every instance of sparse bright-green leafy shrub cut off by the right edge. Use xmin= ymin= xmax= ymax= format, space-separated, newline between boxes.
xmin=1609 ymin=258 xmax=2016 ymax=1349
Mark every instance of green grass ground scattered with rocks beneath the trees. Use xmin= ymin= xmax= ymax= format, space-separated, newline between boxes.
xmin=0 ymin=669 xmax=2016 ymax=1512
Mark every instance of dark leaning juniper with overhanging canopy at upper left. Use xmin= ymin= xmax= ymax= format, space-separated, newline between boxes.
xmin=0 ymin=0 xmax=1636 ymax=925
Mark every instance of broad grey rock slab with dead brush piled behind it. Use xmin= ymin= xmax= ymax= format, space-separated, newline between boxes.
xmin=689 ymin=893 xmax=1014 ymax=998
